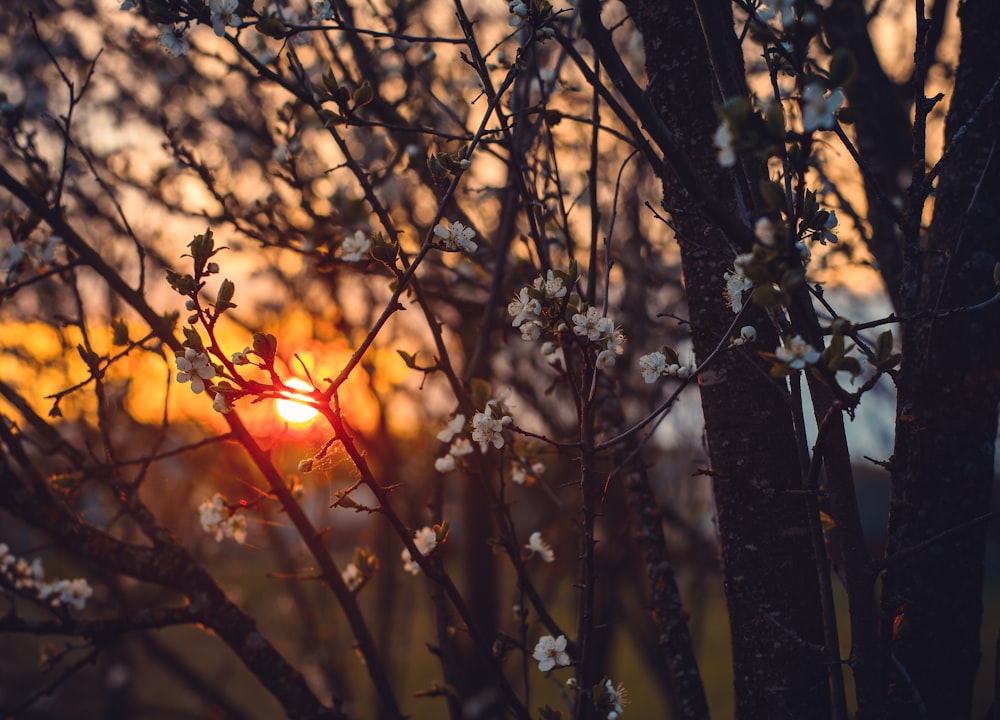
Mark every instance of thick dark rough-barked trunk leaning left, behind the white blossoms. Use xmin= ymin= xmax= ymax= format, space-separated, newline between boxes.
xmin=600 ymin=0 xmax=830 ymax=718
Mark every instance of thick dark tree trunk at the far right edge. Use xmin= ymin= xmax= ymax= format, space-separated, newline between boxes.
xmin=883 ymin=0 xmax=1000 ymax=718
